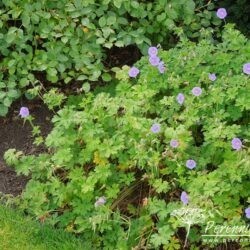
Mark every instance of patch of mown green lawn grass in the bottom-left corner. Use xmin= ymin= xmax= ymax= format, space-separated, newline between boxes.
xmin=0 ymin=204 xmax=84 ymax=250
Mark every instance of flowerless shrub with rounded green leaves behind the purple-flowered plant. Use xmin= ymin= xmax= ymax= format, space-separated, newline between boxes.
xmin=0 ymin=0 xmax=221 ymax=115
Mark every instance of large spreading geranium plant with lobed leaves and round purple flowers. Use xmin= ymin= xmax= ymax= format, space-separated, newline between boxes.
xmin=5 ymin=25 xmax=250 ymax=249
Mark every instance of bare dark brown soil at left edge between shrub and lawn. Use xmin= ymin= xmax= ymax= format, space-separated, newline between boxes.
xmin=0 ymin=100 xmax=52 ymax=196
